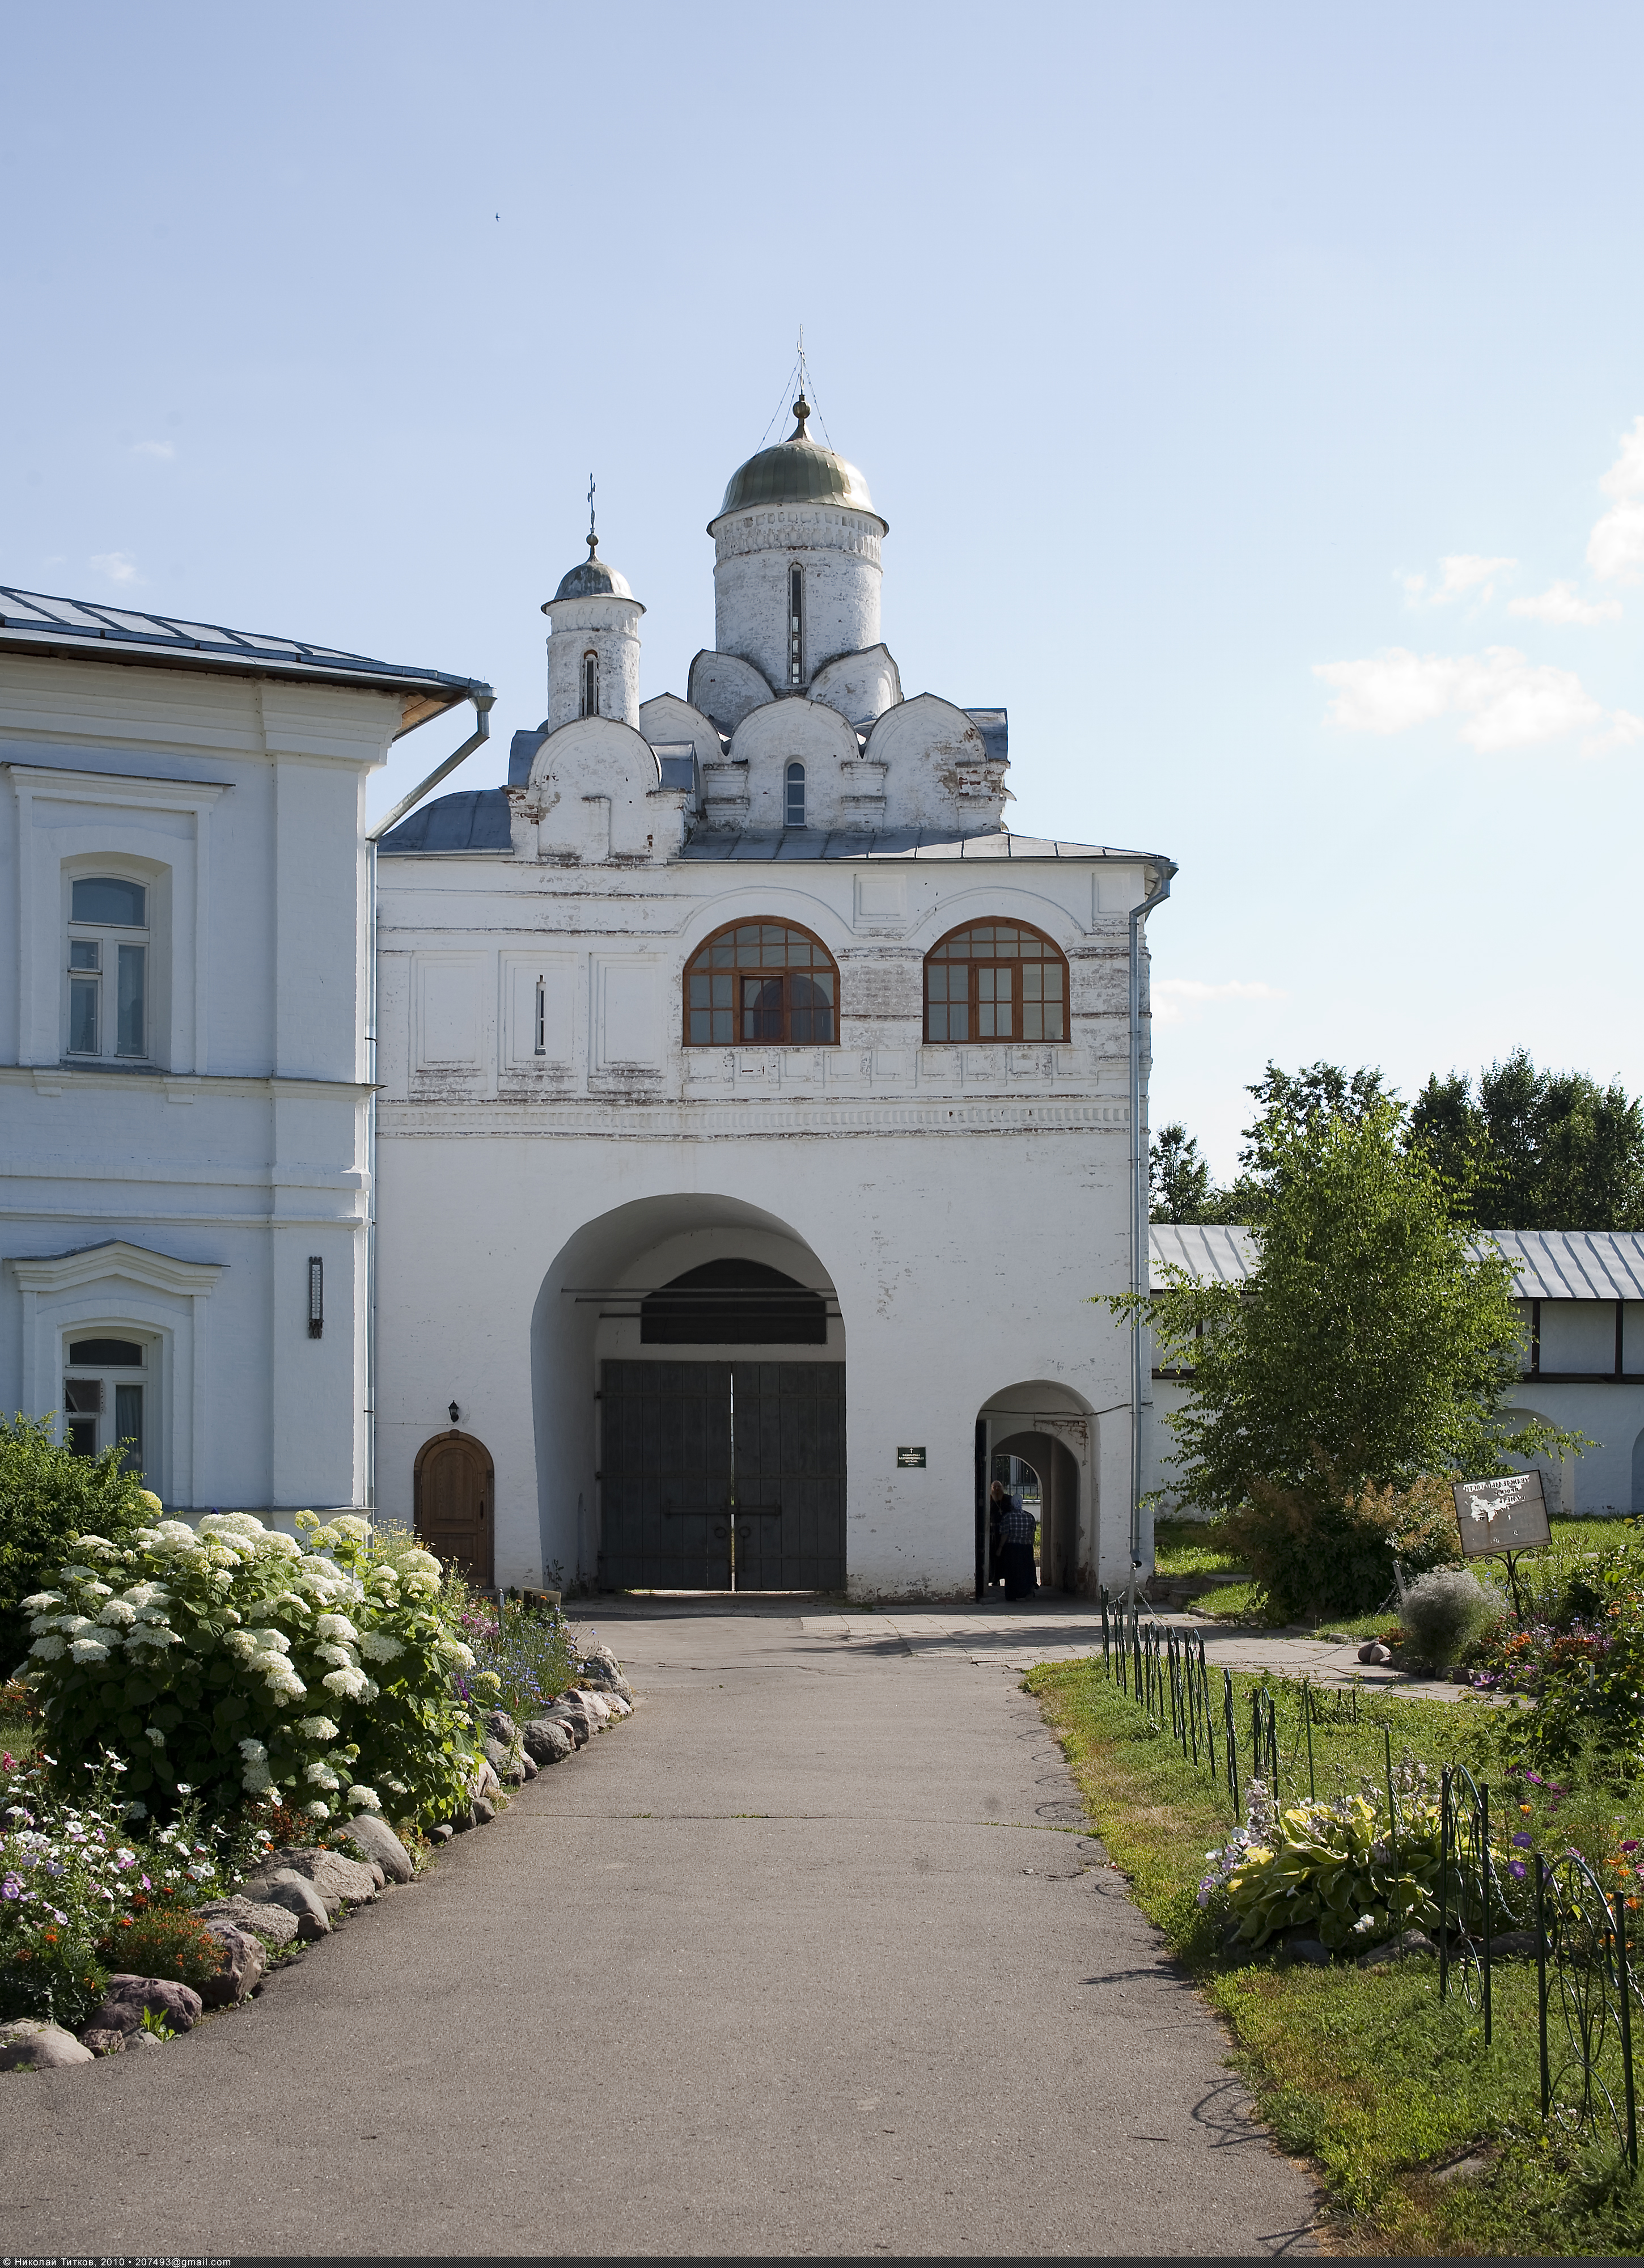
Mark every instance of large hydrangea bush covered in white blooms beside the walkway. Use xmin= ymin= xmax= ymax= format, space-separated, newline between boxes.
xmin=25 ymin=1513 xmax=474 ymax=1821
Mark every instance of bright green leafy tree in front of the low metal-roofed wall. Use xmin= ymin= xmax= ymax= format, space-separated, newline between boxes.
xmin=1111 ymin=1098 xmax=1578 ymax=1606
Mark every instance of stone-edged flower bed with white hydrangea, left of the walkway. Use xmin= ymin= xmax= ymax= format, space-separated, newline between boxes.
xmin=0 ymin=1515 xmax=630 ymax=2068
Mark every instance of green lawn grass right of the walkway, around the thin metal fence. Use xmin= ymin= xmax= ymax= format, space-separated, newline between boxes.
xmin=1027 ymin=1660 xmax=1644 ymax=2257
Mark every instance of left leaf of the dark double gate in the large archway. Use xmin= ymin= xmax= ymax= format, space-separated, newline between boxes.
xmin=599 ymin=1363 xmax=732 ymax=1590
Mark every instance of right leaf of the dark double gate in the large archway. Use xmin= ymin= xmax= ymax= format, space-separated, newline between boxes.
xmin=732 ymin=1363 xmax=846 ymax=1590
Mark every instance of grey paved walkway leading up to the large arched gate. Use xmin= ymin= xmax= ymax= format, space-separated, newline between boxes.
xmin=0 ymin=1606 xmax=1313 ymax=2257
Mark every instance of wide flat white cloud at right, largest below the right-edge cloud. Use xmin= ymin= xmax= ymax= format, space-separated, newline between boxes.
xmin=1313 ymin=646 xmax=1644 ymax=755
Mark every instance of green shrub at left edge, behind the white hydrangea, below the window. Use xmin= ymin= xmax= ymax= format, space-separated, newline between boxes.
xmin=0 ymin=1415 xmax=161 ymax=1676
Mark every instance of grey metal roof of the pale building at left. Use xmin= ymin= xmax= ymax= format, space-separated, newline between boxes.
xmin=0 ymin=585 xmax=490 ymax=733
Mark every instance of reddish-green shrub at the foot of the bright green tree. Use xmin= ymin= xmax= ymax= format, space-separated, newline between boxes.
xmin=1213 ymin=1470 xmax=1460 ymax=1622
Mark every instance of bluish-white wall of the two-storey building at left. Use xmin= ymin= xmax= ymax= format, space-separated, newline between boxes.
xmin=0 ymin=649 xmax=399 ymax=1513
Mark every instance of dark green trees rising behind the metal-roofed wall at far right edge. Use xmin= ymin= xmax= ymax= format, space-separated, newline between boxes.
xmin=1408 ymin=1048 xmax=1644 ymax=1229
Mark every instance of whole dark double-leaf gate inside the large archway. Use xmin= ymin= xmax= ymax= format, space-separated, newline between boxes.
xmin=601 ymin=1363 xmax=846 ymax=1590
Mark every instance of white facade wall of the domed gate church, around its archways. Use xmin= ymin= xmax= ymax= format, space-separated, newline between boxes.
xmin=379 ymin=844 xmax=1147 ymax=1597
